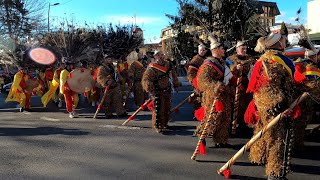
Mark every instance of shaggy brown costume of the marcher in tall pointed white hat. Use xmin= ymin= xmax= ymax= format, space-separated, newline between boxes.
xmin=196 ymin=57 xmax=231 ymax=144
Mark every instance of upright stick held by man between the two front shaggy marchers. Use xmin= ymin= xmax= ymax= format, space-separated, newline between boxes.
xmin=231 ymin=71 xmax=242 ymax=134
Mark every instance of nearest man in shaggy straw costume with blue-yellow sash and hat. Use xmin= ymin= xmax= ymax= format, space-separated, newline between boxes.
xmin=245 ymin=30 xmax=298 ymax=179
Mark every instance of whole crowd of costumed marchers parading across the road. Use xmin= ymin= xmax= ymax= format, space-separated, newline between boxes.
xmin=1 ymin=23 xmax=320 ymax=179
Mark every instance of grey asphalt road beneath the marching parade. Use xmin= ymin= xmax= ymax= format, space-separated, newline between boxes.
xmin=0 ymin=87 xmax=320 ymax=180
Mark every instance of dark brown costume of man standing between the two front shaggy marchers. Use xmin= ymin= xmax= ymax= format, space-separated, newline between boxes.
xmin=228 ymin=54 xmax=255 ymax=133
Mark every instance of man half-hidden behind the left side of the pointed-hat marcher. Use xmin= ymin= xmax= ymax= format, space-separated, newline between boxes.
xmin=187 ymin=44 xmax=207 ymax=110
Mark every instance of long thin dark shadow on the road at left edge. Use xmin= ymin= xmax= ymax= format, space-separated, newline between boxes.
xmin=0 ymin=127 xmax=89 ymax=136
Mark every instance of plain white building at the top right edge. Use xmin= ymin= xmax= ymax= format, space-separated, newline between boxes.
xmin=307 ymin=0 xmax=320 ymax=44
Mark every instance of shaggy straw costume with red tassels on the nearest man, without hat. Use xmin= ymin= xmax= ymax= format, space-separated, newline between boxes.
xmin=245 ymin=50 xmax=294 ymax=177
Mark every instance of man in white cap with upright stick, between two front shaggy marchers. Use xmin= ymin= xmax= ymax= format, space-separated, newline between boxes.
xmin=226 ymin=41 xmax=255 ymax=133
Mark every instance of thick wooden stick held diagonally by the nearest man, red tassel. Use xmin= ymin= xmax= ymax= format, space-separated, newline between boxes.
xmin=217 ymin=92 xmax=309 ymax=175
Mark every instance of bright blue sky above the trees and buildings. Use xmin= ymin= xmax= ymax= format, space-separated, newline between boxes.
xmin=47 ymin=0 xmax=308 ymax=43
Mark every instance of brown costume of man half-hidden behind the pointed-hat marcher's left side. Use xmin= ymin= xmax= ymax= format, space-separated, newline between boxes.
xmin=187 ymin=54 xmax=205 ymax=110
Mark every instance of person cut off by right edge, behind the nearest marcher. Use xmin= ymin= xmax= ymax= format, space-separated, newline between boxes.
xmin=294 ymin=49 xmax=320 ymax=151
